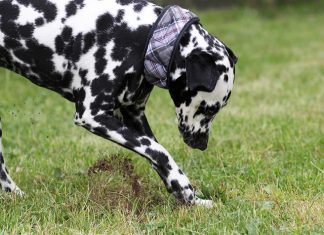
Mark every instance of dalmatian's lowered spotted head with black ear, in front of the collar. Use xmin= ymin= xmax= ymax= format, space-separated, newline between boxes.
xmin=169 ymin=24 xmax=237 ymax=150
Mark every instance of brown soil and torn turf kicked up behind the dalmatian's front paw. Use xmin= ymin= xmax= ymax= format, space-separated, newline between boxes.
xmin=88 ymin=155 xmax=163 ymax=214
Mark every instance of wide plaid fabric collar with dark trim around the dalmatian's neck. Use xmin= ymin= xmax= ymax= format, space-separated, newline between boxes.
xmin=144 ymin=6 xmax=199 ymax=88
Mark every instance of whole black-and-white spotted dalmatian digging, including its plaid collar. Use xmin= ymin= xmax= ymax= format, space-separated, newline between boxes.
xmin=0 ymin=0 xmax=237 ymax=207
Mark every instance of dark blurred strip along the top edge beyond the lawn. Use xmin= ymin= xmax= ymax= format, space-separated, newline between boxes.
xmin=151 ymin=0 xmax=321 ymax=9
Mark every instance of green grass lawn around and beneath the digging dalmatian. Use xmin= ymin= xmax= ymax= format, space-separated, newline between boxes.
xmin=0 ymin=6 xmax=324 ymax=234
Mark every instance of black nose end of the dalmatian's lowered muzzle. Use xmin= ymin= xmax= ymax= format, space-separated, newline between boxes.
xmin=182 ymin=129 xmax=209 ymax=151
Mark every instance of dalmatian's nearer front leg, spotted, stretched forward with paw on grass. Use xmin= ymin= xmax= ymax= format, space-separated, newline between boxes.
xmin=75 ymin=109 xmax=212 ymax=207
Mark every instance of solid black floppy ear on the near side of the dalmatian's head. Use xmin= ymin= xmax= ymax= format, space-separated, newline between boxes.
xmin=186 ymin=51 xmax=220 ymax=92
